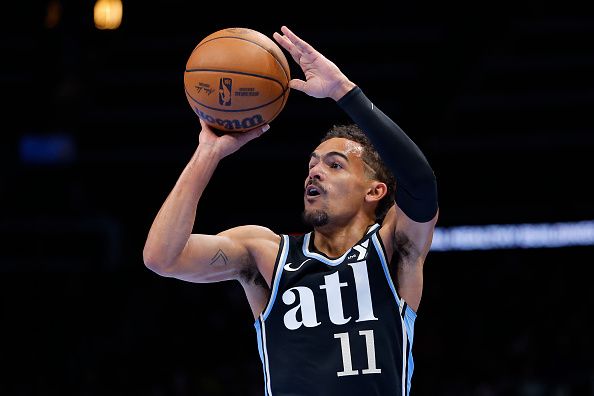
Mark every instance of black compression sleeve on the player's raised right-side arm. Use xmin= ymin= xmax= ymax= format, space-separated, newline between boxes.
xmin=337 ymin=87 xmax=438 ymax=223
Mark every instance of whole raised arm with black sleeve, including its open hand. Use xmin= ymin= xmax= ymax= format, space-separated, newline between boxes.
xmin=273 ymin=26 xmax=438 ymax=311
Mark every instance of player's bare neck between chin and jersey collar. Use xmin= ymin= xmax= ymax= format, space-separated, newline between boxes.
xmin=313 ymin=219 xmax=374 ymax=257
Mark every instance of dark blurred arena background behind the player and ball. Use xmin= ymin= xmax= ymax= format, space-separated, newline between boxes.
xmin=0 ymin=0 xmax=594 ymax=396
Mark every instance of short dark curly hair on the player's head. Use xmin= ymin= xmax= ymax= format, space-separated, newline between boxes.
xmin=322 ymin=124 xmax=396 ymax=223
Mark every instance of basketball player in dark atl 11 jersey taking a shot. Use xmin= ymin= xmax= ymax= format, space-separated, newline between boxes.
xmin=144 ymin=27 xmax=438 ymax=396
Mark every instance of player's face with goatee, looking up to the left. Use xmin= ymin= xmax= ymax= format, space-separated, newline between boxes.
xmin=303 ymin=138 xmax=369 ymax=226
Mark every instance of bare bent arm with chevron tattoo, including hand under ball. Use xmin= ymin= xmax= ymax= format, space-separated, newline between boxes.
xmin=143 ymin=120 xmax=271 ymax=282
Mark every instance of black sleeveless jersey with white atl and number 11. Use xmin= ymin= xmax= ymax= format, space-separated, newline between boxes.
xmin=255 ymin=224 xmax=416 ymax=396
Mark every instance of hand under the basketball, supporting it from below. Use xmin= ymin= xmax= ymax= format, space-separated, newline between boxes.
xmin=198 ymin=120 xmax=270 ymax=159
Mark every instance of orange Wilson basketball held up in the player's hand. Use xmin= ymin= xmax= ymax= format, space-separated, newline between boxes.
xmin=184 ymin=28 xmax=291 ymax=132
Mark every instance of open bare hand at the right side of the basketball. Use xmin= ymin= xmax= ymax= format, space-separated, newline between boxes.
xmin=273 ymin=26 xmax=355 ymax=100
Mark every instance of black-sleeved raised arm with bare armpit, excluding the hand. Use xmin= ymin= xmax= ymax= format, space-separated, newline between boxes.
xmin=338 ymin=87 xmax=438 ymax=311
